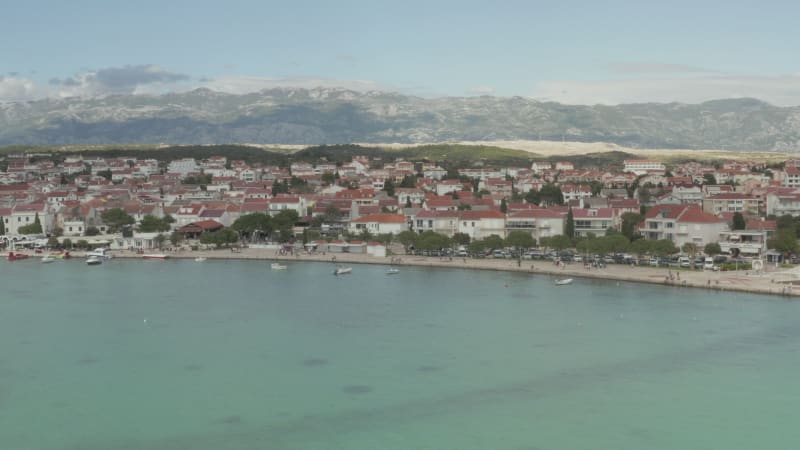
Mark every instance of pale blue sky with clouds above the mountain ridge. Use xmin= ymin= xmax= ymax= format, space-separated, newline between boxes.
xmin=0 ymin=0 xmax=800 ymax=106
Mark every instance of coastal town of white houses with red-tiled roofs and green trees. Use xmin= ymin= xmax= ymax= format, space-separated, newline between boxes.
xmin=0 ymin=152 xmax=800 ymax=276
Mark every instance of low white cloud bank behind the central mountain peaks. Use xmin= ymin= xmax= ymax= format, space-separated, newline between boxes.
xmin=201 ymin=76 xmax=385 ymax=94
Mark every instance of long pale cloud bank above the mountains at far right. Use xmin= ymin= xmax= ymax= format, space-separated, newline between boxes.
xmin=532 ymin=75 xmax=800 ymax=106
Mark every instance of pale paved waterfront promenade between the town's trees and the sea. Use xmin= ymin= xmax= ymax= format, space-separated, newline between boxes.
xmin=101 ymin=248 xmax=800 ymax=297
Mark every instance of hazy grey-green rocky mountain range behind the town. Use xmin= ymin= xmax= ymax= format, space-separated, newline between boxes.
xmin=0 ymin=88 xmax=800 ymax=151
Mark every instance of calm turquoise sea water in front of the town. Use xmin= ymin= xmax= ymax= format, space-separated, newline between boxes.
xmin=0 ymin=260 xmax=800 ymax=450
